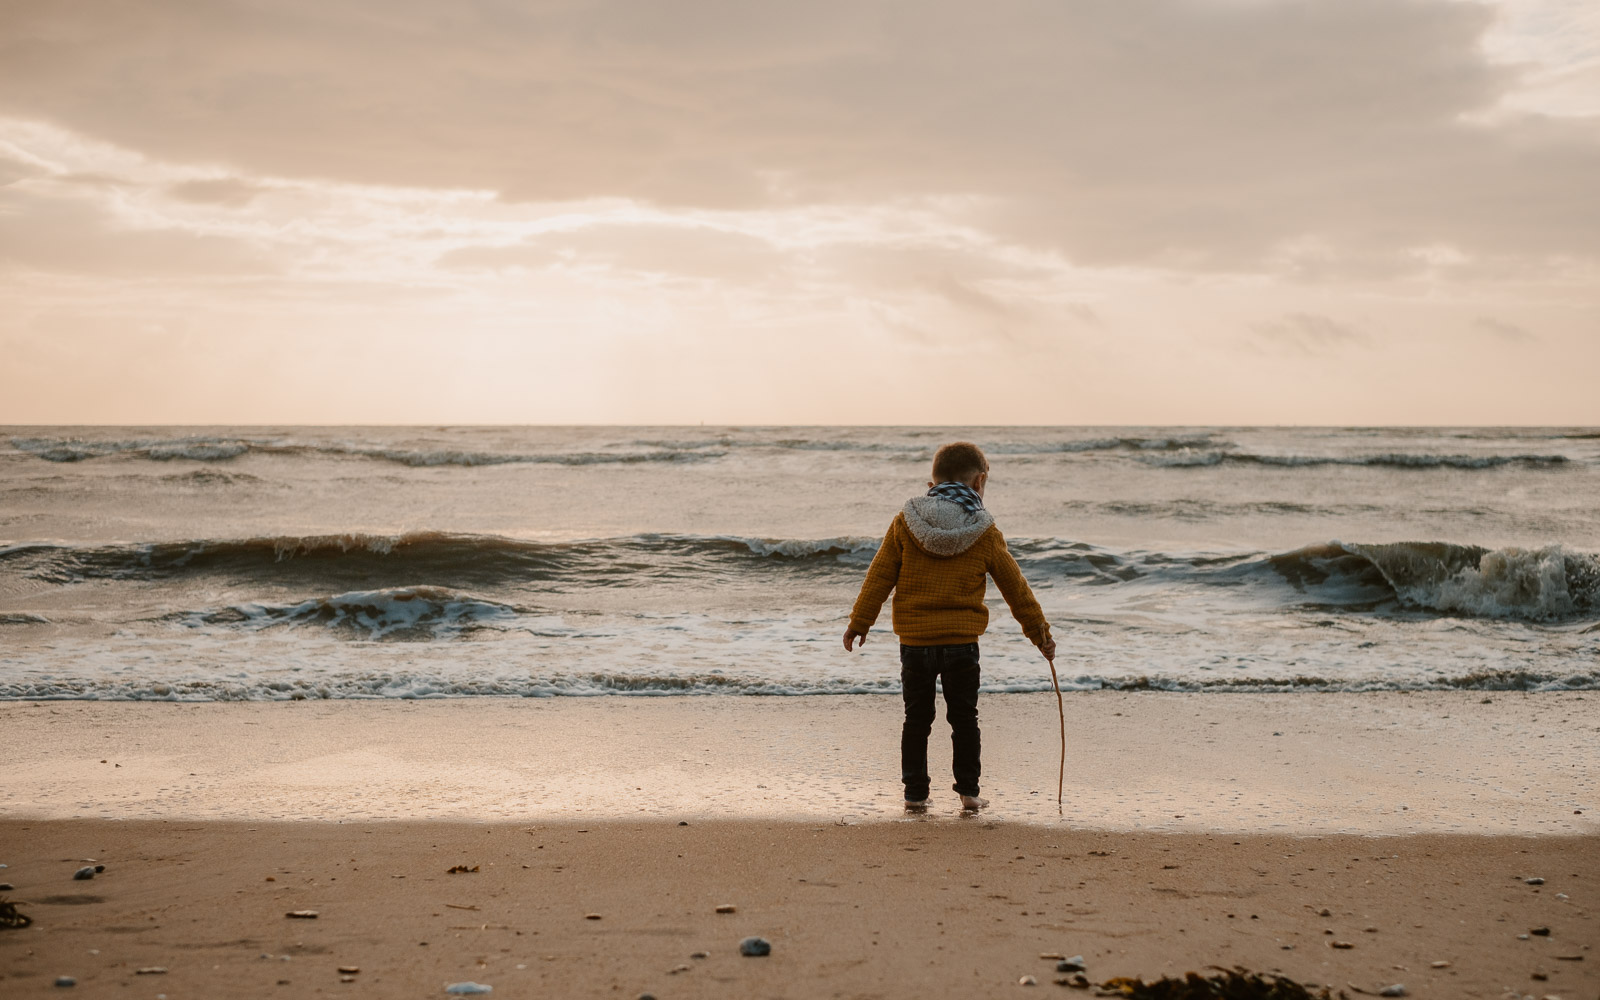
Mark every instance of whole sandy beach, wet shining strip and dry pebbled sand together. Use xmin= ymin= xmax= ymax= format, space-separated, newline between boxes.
xmin=0 ymin=693 xmax=1600 ymax=1000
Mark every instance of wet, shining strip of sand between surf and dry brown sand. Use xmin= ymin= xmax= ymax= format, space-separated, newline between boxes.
xmin=0 ymin=691 xmax=1600 ymax=835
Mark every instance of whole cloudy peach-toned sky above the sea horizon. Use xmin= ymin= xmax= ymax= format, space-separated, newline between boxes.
xmin=0 ymin=0 xmax=1600 ymax=426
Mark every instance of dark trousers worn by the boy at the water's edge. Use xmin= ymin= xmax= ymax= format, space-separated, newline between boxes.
xmin=901 ymin=642 xmax=982 ymax=802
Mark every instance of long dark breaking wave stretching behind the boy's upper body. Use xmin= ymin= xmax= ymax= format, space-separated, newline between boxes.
xmin=0 ymin=531 xmax=1600 ymax=622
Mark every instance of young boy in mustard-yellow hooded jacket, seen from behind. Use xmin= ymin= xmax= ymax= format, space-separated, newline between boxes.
xmin=845 ymin=442 xmax=1056 ymax=811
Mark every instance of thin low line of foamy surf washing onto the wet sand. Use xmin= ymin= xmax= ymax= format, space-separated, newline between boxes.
xmin=0 ymin=669 xmax=1600 ymax=701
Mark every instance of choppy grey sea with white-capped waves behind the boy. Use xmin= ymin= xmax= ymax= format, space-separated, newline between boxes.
xmin=0 ymin=426 xmax=1600 ymax=701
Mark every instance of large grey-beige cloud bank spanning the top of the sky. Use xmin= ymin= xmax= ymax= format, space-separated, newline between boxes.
xmin=0 ymin=0 xmax=1600 ymax=270
